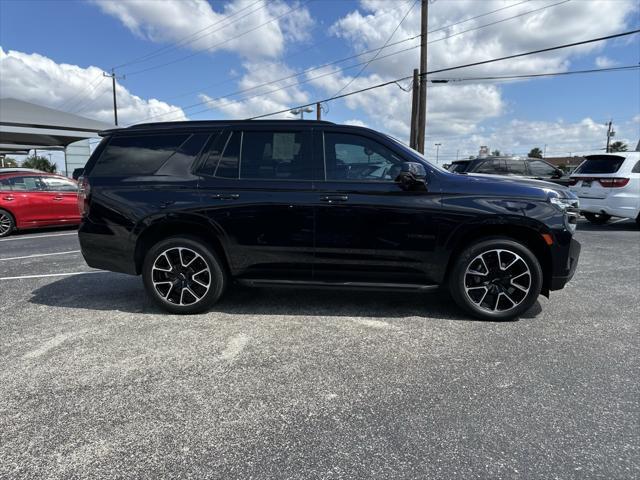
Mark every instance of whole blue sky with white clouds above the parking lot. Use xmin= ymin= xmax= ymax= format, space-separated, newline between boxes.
xmin=0 ymin=0 xmax=640 ymax=170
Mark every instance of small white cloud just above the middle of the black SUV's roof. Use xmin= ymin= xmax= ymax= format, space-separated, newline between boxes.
xmin=200 ymin=61 xmax=309 ymax=118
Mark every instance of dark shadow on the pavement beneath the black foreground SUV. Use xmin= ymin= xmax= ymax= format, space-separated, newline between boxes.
xmin=29 ymin=273 xmax=541 ymax=321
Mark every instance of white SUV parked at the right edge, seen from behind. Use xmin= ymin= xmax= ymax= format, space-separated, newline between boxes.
xmin=569 ymin=152 xmax=640 ymax=225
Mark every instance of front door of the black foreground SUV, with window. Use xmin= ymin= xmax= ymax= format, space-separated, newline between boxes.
xmin=314 ymin=128 xmax=439 ymax=284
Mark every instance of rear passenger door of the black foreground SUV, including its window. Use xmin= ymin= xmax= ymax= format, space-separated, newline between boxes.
xmin=198 ymin=124 xmax=315 ymax=280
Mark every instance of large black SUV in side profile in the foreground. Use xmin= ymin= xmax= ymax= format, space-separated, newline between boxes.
xmin=79 ymin=120 xmax=580 ymax=319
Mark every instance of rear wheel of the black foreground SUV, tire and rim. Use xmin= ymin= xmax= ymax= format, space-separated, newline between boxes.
xmin=142 ymin=236 xmax=227 ymax=315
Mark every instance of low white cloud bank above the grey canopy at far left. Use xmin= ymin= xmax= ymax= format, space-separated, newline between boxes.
xmin=0 ymin=47 xmax=186 ymax=124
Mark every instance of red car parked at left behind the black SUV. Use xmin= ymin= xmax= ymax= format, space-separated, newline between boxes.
xmin=0 ymin=171 xmax=80 ymax=237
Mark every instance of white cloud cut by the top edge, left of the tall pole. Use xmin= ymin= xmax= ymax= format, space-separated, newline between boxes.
xmin=93 ymin=0 xmax=312 ymax=58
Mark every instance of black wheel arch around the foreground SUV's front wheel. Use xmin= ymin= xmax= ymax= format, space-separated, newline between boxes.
xmin=445 ymin=224 xmax=553 ymax=297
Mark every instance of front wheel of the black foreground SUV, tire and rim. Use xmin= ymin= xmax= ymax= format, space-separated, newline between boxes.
xmin=448 ymin=238 xmax=542 ymax=321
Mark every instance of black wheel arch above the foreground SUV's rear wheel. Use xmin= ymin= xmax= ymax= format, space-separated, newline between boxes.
xmin=134 ymin=219 xmax=231 ymax=275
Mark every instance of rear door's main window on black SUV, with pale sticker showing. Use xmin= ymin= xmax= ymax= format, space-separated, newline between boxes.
xmin=240 ymin=131 xmax=313 ymax=180
